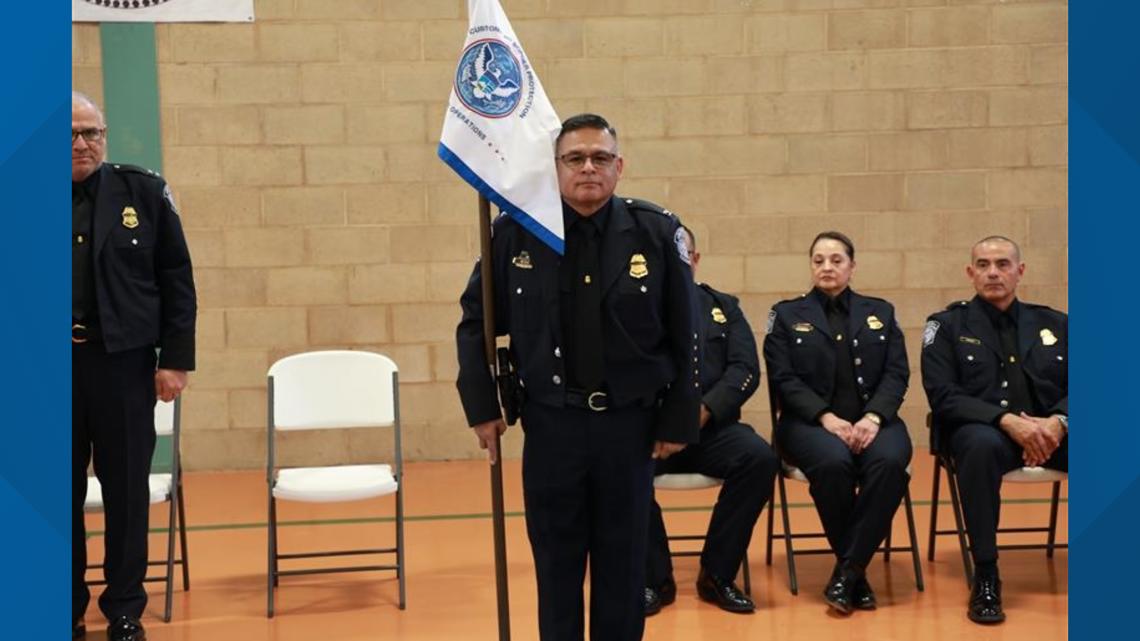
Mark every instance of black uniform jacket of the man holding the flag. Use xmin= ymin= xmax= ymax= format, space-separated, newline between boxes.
xmin=456 ymin=197 xmax=700 ymax=443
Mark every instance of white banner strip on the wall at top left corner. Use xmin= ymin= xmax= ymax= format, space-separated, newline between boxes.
xmin=72 ymin=0 xmax=253 ymax=23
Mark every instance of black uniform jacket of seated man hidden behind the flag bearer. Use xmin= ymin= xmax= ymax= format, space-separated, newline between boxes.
xmin=697 ymin=283 xmax=760 ymax=429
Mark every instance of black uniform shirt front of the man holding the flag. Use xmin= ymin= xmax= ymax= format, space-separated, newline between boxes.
xmin=559 ymin=201 xmax=612 ymax=392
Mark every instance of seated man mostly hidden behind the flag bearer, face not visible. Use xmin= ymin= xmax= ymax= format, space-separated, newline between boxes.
xmin=645 ymin=227 xmax=780 ymax=615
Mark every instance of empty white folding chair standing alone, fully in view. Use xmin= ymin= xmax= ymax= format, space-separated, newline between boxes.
xmin=266 ymin=350 xmax=405 ymax=617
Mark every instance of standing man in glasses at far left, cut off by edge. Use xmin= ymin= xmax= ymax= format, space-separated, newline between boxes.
xmin=72 ymin=92 xmax=197 ymax=641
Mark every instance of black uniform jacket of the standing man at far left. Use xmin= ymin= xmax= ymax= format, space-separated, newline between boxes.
xmin=92 ymin=163 xmax=197 ymax=371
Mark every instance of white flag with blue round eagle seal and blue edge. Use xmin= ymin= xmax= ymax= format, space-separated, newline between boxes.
xmin=439 ymin=0 xmax=564 ymax=253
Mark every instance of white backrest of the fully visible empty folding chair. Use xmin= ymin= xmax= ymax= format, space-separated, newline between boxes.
xmin=269 ymin=350 xmax=398 ymax=430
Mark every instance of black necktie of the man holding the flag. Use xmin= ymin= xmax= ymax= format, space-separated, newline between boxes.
xmin=573 ymin=218 xmax=605 ymax=391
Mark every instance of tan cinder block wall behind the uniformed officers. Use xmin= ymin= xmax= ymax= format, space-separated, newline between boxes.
xmin=72 ymin=0 xmax=1068 ymax=469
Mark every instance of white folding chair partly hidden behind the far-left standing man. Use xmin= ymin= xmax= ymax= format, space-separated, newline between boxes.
xmin=83 ymin=397 xmax=190 ymax=623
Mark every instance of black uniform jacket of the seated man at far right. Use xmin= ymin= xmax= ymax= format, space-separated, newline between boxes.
xmin=922 ymin=297 xmax=1068 ymax=429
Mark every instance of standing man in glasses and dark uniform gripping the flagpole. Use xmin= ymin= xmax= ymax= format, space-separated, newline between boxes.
xmin=456 ymin=114 xmax=700 ymax=641
